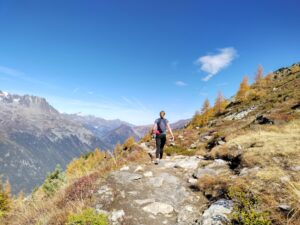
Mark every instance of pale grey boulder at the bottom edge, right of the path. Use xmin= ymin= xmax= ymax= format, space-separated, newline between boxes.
xmin=202 ymin=199 xmax=233 ymax=225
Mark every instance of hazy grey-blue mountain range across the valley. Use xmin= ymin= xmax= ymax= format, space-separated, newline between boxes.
xmin=0 ymin=91 xmax=186 ymax=193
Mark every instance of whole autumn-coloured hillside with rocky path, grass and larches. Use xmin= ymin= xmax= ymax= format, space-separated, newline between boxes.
xmin=2 ymin=64 xmax=300 ymax=225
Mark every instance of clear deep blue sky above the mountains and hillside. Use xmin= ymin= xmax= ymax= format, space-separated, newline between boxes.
xmin=0 ymin=0 xmax=300 ymax=124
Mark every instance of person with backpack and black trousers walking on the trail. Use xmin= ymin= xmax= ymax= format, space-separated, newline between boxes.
xmin=152 ymin=111 xmax=174 ymax=164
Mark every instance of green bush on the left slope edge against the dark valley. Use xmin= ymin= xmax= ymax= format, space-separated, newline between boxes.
xmin=42 ymin=165 xmax=66 ymax=197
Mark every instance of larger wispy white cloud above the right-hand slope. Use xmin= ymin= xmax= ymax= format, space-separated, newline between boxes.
xmin=195 ymin=47 xmax=237 ymax=81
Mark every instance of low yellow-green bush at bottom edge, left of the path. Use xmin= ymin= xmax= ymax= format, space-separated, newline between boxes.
xmin=66 ymin=209 xmax=108 ymax=225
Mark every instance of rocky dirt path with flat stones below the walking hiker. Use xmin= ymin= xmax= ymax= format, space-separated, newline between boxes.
xmin=95 ymin=145 xmax=231 ymax=225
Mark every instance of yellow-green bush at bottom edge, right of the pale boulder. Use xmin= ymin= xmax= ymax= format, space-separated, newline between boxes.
xmin=228 ymin=187 xmax=271 ymax=225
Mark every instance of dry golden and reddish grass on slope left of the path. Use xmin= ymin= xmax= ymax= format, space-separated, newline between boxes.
xmin=0 ymin=145 xmax=149 ymax=225
